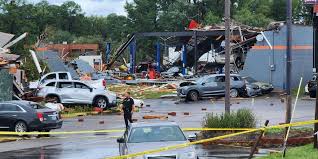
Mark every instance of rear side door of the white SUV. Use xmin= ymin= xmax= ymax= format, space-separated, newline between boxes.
xmin=56 ymin=82 xmax=76 ymax=103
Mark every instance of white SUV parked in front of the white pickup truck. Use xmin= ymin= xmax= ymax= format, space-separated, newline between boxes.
xmin=37 ymin=80 xmax=117 ymax=109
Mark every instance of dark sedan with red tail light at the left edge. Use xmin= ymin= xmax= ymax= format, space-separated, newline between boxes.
xmin=0 ymin=101 xmax=63 ymax=132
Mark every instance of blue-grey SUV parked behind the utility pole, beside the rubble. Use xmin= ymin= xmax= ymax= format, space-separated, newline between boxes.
xmin=177 ymin=74 xmax=246 ymax=101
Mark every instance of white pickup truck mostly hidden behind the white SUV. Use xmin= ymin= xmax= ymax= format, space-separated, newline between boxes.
xmin=29 ymin=72 xmax=106 ymax=89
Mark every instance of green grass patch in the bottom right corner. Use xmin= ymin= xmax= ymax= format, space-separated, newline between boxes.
xmin=259 ymin=144 xmax=318 ymax=159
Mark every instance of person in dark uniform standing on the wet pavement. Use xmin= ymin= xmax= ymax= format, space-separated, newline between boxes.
xmin=123 ymin=92 xmax=135 ymax=129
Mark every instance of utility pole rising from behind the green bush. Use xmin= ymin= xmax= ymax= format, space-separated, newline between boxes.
xmin=224 ymin=0 xmax=231 ymax=113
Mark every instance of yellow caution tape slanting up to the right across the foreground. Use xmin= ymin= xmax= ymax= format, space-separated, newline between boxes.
xmin=109 ymin=120 xmax=318 ymax=159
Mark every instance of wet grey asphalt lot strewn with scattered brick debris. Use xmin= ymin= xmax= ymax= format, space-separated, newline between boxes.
xmin=0 ymin=98 xmax=314 ymax=159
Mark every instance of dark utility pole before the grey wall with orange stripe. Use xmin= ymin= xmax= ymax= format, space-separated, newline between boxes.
xmin=285 ymin=0 xmax=292 ymax=132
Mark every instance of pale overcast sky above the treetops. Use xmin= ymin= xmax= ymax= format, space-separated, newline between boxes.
xmin=26 ymin=0 xmax=132 ymax=15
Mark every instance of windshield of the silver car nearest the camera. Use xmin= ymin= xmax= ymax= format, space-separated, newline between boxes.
xmin=128 ymin=126 xmax=186 ymax=143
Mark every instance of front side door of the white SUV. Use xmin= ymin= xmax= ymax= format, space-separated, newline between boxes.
xmin=74 ymin=82 xmax=93 ymax=103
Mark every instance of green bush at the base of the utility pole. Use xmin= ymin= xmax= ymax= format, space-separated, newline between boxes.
xmin=203 ymin=108 xmax=256 ymax=128
